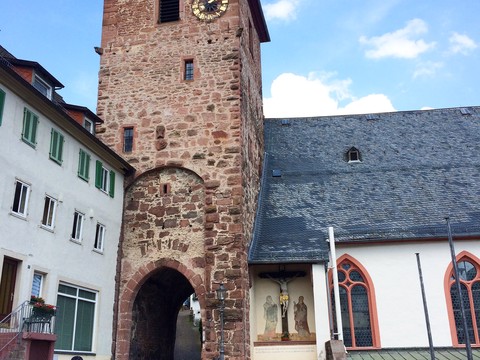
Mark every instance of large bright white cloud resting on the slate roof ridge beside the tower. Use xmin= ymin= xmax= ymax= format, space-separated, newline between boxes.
xmin=263 ymin=73 xmax=395 ymax=118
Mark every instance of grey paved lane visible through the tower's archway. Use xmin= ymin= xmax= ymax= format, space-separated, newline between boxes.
xmin=174 ymin=310 xmax=201 ymax=360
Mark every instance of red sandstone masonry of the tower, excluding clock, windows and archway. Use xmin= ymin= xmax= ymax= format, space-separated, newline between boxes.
xmin=97 ymin=0 xmax=263 ymax=360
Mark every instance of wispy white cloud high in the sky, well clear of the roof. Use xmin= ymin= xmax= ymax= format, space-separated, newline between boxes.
xmin=359 ymin=19 xmax=435 ymax=59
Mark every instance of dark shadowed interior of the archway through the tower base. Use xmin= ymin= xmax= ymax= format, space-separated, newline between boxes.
xmin=130 ymin=267 xmax=200 ymax=360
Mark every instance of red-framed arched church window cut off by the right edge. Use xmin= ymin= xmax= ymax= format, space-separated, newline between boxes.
xmin=445 ymin=251 xmax=480 ymax=346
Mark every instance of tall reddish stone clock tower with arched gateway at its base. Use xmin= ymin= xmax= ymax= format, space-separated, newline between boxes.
xmin=98 ymin=0 xmax=269 ymax=360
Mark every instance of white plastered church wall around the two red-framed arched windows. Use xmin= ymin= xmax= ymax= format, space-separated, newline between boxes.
xmin=337 ymin=241 xmax=480 ymax=348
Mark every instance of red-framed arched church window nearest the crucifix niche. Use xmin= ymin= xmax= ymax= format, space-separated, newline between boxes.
xmin=330 ymin=255 xmax=380 ymax=349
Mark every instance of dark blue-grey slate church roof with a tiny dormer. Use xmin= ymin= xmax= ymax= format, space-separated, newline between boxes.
xmin=249 ymin=107 xmax=480 ymax=263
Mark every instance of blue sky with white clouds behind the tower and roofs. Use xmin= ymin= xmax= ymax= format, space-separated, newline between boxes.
xmin=0 ymin=0 xmax=480 ymax=117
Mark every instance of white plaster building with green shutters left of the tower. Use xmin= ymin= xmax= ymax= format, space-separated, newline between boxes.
xmin=0 ymin=48 xmax=134 ymax=359
